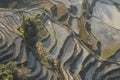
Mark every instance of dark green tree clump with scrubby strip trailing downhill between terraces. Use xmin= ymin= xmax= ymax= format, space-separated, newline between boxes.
xmin=13 ymin=13 xmax=60 ymax=77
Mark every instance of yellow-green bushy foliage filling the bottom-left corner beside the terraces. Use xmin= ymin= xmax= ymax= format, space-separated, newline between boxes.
xmin=0 ymin=62 xmax=30 ymax=80
